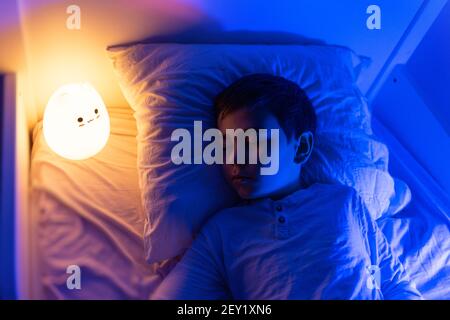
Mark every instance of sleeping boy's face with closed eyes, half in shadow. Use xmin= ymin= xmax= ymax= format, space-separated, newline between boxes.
xmin=218 ymin=109 xmax=301 ymax=199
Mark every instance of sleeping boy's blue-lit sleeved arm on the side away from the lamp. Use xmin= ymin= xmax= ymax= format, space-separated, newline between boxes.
xmin=357 ymin=197 xmax=422 ymax=300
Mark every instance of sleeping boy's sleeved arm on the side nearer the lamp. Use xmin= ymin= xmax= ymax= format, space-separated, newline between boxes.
xmin=151 ymin=220 xmax=230 ymax=300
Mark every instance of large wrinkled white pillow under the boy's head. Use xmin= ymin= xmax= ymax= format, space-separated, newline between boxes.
xmin=109 ymin=44 xmax=408 ymax=263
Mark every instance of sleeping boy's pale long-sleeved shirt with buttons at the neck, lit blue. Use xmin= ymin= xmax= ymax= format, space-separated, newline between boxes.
xmin=152 ymin=184 xmax=421 ymax=299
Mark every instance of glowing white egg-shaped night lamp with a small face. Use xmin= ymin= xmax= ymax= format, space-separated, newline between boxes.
xmin=44 ymin=83 xmax=110 ymax=160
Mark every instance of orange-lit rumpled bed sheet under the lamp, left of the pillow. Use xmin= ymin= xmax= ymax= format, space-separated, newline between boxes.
xmin=31 ymin=107 xmax=162 ymax=299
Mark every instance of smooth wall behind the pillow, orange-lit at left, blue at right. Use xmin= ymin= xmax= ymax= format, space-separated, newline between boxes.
xmin=8 ymin=0 xmax=424 ymax=129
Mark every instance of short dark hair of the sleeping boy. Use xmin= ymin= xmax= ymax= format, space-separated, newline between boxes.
xmin=214 ymin=73 xmax=316 ymax=138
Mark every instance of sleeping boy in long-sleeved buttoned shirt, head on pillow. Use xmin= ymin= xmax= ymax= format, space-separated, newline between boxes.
xmin=152 ymin=74 xmax=421 ymax=299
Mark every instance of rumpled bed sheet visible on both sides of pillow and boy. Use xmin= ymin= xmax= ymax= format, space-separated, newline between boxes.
xmin=31 ymin=107 xmax=450 ymax=299
